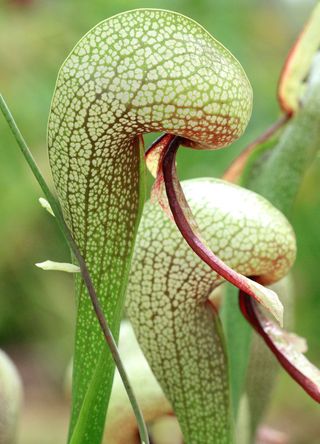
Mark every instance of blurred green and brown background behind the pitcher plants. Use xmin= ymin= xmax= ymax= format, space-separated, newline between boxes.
xmin=0 ymin=0 xmax=320 ymax=444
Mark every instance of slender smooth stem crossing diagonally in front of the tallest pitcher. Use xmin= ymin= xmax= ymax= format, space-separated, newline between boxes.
xmin=0 ymin=94 xmax=149 ymax=444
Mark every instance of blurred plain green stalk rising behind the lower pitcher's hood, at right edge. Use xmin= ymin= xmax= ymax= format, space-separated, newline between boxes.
xmin=245 ymin=56 xmax=320 ymax=215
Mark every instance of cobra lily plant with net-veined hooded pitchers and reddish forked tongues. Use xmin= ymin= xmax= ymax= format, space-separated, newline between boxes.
xmin=1 ymin=6 xmax=320 ymax=444
